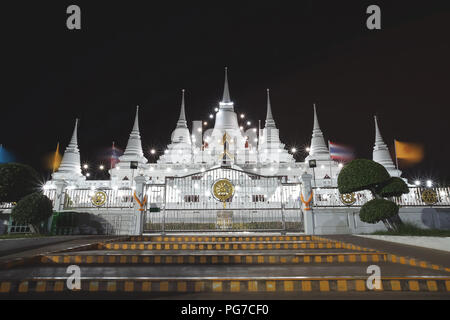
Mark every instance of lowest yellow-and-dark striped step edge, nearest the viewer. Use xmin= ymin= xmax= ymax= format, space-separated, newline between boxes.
xmin=0 ymin=277 xmax=450 ymax=297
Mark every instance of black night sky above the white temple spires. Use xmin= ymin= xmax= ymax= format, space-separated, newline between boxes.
xmin=0 ymin=0 xmax=450 ymax=183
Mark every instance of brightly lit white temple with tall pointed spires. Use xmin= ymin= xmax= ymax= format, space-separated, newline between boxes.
xmin=44 ymin=69 xmax=412 ymax=234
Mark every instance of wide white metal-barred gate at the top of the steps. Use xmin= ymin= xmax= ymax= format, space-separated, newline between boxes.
xmin=144 ymin=167 xmax=303 ymax=232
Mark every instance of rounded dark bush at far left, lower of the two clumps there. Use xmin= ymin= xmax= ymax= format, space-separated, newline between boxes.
xmin=12 ymin=192 xmax=53 ymax=232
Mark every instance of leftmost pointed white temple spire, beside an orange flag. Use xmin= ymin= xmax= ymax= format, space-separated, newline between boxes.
xmin=53 ymin=119 xmax=82 ymax=179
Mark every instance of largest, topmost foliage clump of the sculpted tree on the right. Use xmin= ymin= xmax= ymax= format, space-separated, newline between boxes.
xmin=338 ymin=159 xmax=390 ymax=193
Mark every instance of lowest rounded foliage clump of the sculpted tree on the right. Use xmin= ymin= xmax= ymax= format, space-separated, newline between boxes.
xmin=359 ymin=199 xmax=399 ymax=223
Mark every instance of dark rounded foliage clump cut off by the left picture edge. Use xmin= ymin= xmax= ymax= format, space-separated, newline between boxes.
xmin=0 ymin=163 xmax=38 ymax=202
